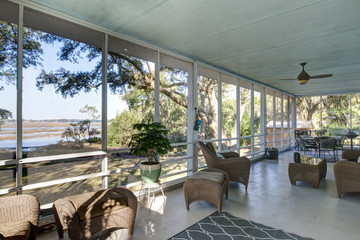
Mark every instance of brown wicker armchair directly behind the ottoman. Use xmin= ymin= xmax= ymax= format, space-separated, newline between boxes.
xmin=199 ymin=142 xmax=250 ymax=191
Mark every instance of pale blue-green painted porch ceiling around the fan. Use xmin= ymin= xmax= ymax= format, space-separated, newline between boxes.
xmin=32 ymin=0 xmax=360 ymax=96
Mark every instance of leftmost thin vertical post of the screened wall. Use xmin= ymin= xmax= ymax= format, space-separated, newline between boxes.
xmin=16 ymin=5 xmax=24 ymax=194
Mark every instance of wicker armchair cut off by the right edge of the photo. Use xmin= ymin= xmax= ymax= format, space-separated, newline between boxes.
xmin=334 ymin=160 xmax=360 ymax=198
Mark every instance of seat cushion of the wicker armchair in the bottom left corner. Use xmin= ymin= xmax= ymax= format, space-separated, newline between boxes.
xmin=0 ymin=221 xmax=31 ymax=240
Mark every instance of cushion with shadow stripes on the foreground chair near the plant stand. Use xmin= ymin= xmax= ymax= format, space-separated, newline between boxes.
xmin=65 ymin=189 xmax=128 ymax=220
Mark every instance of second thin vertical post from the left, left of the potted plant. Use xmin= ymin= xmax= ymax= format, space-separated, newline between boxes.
xmin=101 ymin=33 xmax=109 ymax=189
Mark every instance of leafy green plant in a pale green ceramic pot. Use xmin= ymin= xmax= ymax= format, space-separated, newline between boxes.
xmin=129 ymin=122 xmax=171 ymax=183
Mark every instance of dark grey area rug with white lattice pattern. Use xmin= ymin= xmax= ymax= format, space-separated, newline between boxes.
xmin=169 ymin=212 xmax=312 ymax=240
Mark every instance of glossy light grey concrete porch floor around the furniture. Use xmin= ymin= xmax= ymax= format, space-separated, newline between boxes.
xmin=38 ymin=151 xmax=360 ymax=240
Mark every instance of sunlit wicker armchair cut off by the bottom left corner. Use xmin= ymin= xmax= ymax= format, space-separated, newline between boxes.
xmin=0 ymin=195 xmax=40 ymax=240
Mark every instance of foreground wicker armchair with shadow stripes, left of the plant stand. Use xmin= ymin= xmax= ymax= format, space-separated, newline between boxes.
xmin=53 ymin=187 xmax=137 ymax=240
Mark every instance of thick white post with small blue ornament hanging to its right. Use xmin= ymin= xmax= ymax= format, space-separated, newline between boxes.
xmin=186 ymin=64 xmax=198 ymax=175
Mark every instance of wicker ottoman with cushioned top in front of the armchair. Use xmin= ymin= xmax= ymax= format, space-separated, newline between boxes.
xmin=183 ymin=168 xmax=229 ymax=213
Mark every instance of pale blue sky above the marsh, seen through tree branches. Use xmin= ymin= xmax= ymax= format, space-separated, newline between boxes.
xmin=0 ymin=39 xmax=127 ymax=120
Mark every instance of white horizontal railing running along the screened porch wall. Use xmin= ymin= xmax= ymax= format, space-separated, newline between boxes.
xmin=0 ymin=137 xmax=291 ymax=212
